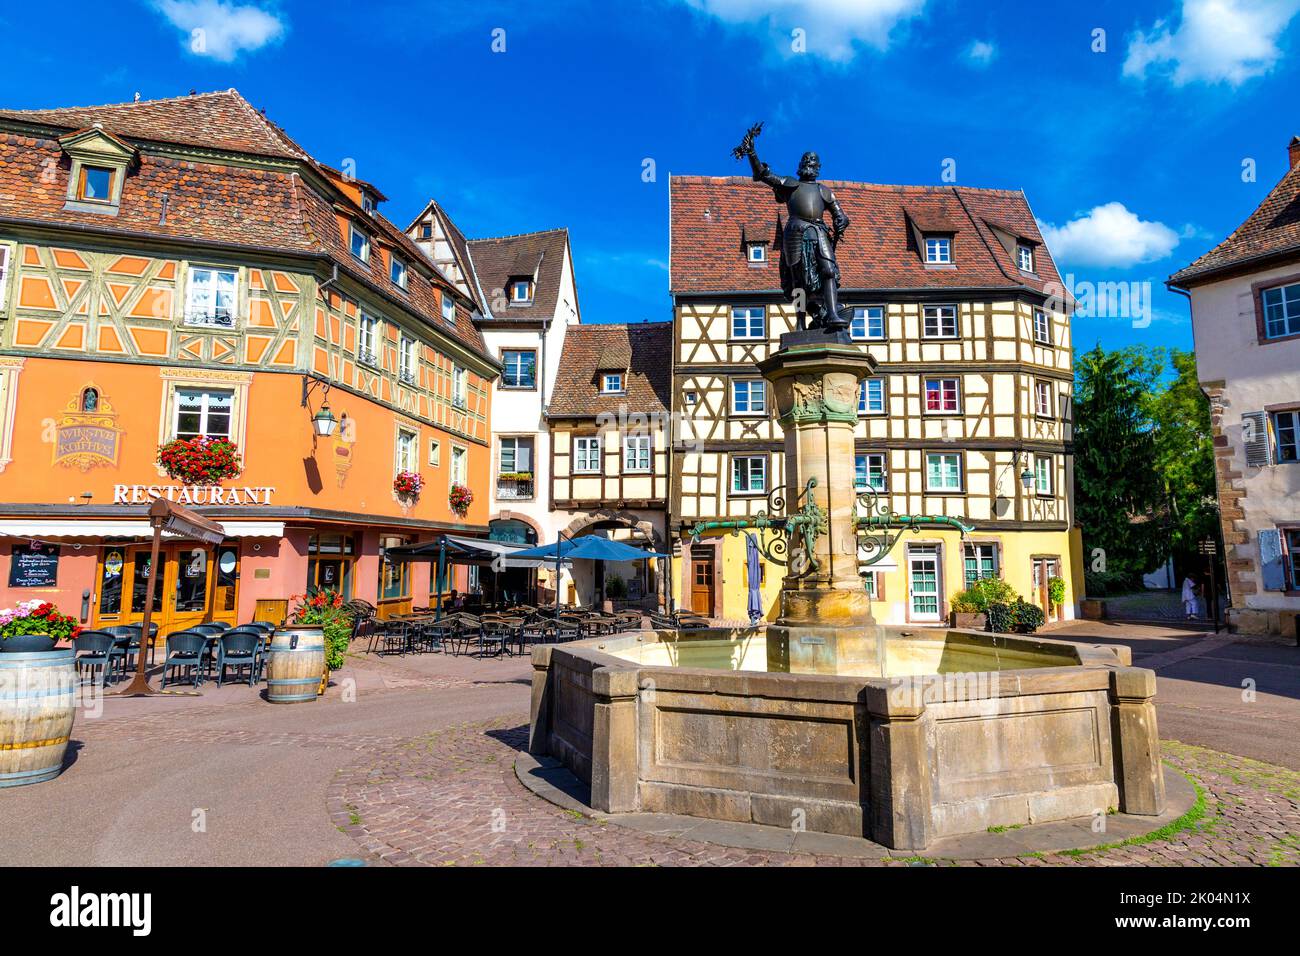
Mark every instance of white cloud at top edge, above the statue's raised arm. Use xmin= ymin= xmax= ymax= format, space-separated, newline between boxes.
xmin=684 ymin=0 xmax=926 ymax=62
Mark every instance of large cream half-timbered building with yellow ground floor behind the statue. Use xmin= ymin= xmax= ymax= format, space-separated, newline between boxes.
xmin=671 ymin=177 xmax=1082 ymax=624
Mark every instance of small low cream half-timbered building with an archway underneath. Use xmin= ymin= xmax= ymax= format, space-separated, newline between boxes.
xmin=547 ymin=323 xmax=672 ymax=610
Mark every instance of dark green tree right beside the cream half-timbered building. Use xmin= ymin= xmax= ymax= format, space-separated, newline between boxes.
xmin=1074 ymin=345 xmax=1169 ymax=578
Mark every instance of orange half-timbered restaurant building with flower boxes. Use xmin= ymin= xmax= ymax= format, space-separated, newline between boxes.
xmin=0 ymin=90 xmax=499 ymax=633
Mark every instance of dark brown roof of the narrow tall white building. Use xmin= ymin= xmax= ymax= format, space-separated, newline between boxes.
xmin=467 ymin=228 xmax=568 ymax=320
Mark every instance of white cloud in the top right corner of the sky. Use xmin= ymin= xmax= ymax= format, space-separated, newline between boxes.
xmin=1125 ymin=0 xmax=1300 ymax=86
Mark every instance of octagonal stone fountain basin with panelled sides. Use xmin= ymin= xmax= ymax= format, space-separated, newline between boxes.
xmin=529 ymin=627 xmax=1165 ymax=849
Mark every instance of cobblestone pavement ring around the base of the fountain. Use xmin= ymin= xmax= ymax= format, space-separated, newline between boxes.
xmin=328 ymin=714 xmax=1300 ymax=866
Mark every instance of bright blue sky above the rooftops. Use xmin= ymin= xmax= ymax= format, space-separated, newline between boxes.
xmin=0 ymin=0 xmax=1300 ymax=356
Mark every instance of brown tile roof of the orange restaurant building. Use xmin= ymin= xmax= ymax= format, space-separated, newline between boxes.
xmin=0 ymin=90 xmax=484 ymax=352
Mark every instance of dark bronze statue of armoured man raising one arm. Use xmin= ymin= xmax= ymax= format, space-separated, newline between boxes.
xmin=733 ymin=124 xmax=849 ymax=332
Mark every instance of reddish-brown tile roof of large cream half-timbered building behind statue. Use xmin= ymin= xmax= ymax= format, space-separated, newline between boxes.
xmin=670 ymin=176 xmax=1061 ymax=295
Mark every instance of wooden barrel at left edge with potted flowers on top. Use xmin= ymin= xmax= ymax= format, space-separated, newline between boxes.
xmin=0 ymin=649 xmax=77 ymax=787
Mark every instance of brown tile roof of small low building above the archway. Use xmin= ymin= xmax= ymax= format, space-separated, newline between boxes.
xmin=549 ymin=323 xmax=672 ymax=419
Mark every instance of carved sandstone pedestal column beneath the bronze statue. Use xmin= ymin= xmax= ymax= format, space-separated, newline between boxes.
xmin=758 ymin=333 xmax=876 ymax=627
